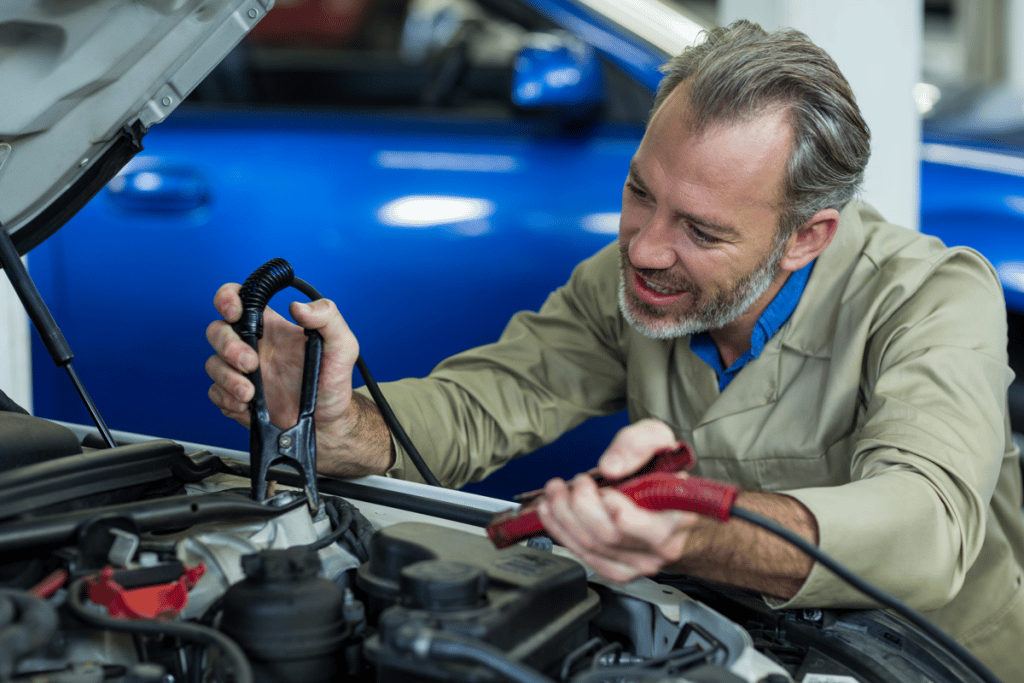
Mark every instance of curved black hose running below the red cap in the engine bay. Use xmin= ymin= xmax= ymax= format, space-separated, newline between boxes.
xmin=67 ymin=578 xmax=253 ymax=683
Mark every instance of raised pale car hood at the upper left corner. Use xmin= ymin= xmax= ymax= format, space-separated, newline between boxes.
xmin=0 ymin=0 xmax=273 ymax=254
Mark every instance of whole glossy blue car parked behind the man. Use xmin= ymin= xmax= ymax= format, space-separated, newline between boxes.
xmin=24 ymin=0 xmax=1024 ymax=497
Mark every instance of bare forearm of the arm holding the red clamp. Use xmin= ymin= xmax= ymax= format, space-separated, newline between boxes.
xmin=667 ymin=492 xmax=818 ymax=598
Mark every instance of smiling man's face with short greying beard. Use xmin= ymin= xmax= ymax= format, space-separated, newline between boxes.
xmin=618 ymin=83 xmax=791 ymax=339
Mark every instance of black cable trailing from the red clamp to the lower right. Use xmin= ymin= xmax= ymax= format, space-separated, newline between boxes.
xmin=729 ymin=506 xmax=1002 ymax=683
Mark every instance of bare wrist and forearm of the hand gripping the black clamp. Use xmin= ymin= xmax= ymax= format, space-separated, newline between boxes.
xmin=316 ymin=392 xmax=395 ymax=477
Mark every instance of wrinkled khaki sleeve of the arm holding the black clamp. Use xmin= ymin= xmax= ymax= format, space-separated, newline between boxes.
xmin=360 ymin=245 xmax=626 ymax=486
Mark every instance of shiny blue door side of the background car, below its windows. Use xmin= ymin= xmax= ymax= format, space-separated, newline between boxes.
xmin=31 ymin=105 xmax=641 ymax=493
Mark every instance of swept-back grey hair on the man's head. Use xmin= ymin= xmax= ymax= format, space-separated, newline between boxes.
xmin=654 ymin=19 xmax=870 ymax=241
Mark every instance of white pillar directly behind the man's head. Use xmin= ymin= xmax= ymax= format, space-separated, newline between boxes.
xmin=718 ymin=0 xmax=925 ymax=229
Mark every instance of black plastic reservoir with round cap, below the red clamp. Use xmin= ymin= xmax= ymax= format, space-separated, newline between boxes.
xmin=357 ymin=522 xmax=600 ymax=683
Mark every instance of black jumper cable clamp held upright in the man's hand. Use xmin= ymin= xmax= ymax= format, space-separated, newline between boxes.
xmin=232 ymin=258 xmax=324 ymax=514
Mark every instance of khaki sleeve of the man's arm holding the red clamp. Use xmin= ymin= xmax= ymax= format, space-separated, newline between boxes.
xmin=773 ymin=250 xmax=1012 ymax=610
